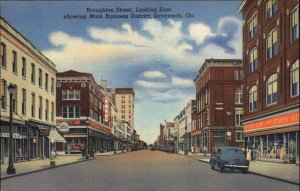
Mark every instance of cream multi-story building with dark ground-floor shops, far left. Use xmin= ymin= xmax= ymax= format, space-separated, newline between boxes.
xmin=0 ymin=18 xmax=64 ymax=162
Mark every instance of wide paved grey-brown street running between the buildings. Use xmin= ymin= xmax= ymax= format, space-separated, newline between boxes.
xmin=1 ymin=151 xmax=299 ymax=191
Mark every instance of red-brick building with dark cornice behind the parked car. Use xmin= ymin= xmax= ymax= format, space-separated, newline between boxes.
xmin=194 ymin=59 xmax=244 ymax=152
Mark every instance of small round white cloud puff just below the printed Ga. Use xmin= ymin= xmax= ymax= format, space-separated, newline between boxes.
xmin=189 ymin=23 xmax=214 ymax=44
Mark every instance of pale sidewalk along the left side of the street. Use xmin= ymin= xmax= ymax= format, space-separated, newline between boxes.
xmin=1 ymin=151 xmax=125 ymax=179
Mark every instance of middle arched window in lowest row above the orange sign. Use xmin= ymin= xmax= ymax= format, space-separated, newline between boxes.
xmin=266 ymin=74 xmax=278 ymax=105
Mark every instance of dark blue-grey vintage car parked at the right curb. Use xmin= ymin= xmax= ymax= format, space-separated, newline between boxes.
xmin=210 ymin=147 xmax=249 ymax=173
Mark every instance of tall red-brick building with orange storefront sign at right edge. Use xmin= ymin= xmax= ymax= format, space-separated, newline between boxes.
xmin=238 ymin=0 xmax=300 ymax=161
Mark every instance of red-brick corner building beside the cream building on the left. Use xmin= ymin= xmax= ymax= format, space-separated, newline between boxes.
xmin=56 ymin=70 xmax=115 ymax=153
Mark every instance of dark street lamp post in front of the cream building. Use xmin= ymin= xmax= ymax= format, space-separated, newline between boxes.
xmin=7 ymin=83 xmax=16 ymax=174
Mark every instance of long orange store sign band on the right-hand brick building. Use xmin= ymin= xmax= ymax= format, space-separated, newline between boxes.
xmin=244 ymin=112 xmax=299 ymax=132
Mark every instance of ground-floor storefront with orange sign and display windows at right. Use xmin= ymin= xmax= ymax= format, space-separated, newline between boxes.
xmin=244 ymin=111 xmax=300 ymax=162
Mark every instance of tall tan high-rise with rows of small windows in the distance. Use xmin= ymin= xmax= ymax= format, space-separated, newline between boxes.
xmin=113 ymin=88 xmax=134 ymax=129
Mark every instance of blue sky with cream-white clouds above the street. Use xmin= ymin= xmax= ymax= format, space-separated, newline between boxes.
xmin=0 ymin=0 xmax=242 ymax=144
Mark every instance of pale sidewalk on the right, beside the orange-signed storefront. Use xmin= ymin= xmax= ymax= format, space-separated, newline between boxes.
xmin=199 ymin=158 xmax=299 ymax=185
